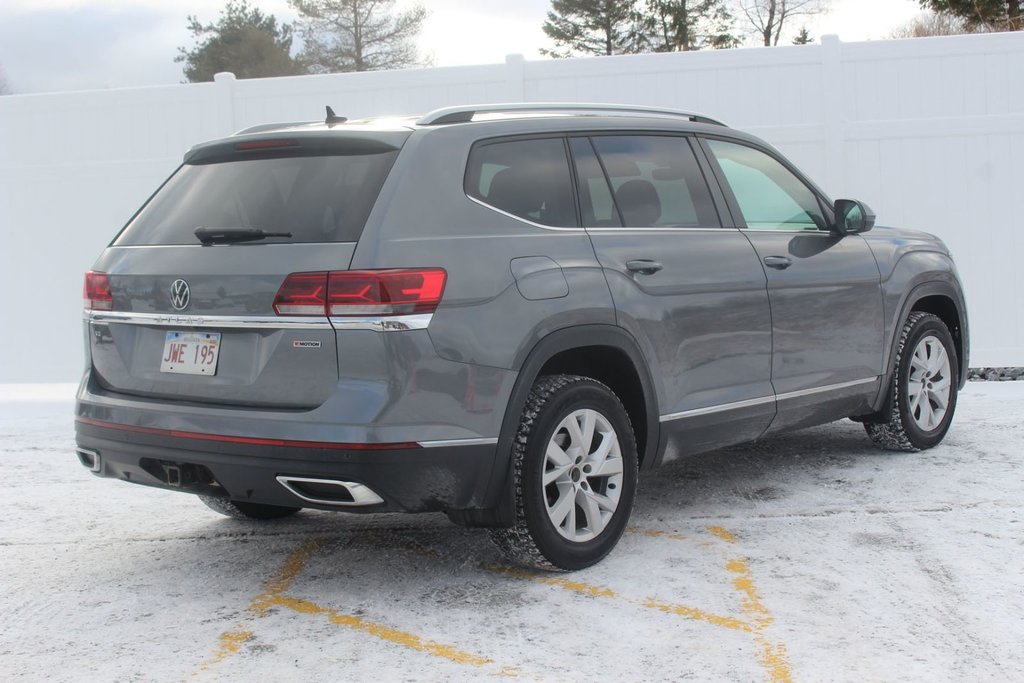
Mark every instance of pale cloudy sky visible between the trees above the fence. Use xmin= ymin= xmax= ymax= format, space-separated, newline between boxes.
xmin=0 ymin=0 xmax=920 ymax=93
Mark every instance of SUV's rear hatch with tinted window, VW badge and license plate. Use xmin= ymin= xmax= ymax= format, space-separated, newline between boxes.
xmin=86 ymin=130 xmax=409 ymax=410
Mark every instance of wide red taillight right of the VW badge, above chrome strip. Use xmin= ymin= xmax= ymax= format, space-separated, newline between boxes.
xmin=273 ymin=268 xmax=446 ymax=315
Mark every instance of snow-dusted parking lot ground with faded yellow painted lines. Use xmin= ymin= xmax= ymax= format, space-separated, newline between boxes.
xmin=0 ymin=382 xmax=1024 ymax=682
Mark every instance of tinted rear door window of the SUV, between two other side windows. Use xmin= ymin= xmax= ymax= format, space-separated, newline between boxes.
xmin=584 ymin=135 xmax=721 ymax=227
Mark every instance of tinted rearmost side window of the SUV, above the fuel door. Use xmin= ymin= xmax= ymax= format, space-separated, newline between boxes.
xmin=466 ymin=137 xmax=577 ymax=227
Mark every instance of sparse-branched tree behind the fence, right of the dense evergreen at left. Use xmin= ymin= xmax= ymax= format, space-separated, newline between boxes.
xmin=289 ymin=0 xmax=427 ymax=74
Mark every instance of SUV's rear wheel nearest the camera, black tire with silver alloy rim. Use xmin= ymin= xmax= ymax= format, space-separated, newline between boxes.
xmin=490 ymin=375 xmax=638 ymax=570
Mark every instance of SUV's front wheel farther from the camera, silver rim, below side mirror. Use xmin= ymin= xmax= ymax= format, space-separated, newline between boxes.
xmin=864 ymin=311 xmax=959 ymax=452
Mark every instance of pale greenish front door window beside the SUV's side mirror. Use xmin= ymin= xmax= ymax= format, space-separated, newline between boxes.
xmin=708 ymin=140 xmax=827 ymax=230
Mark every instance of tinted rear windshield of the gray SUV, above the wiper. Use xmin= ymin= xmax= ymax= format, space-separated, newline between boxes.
xmin=114 ymin=151 xmax=398 ymax=247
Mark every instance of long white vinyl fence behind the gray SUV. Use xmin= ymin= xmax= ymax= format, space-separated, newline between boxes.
xmin=0 ymin=33 xmax=1024 ymax=382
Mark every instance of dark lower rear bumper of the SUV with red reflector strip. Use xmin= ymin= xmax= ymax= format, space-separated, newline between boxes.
xmin=75 ymin=420 xmax=496 ymax=512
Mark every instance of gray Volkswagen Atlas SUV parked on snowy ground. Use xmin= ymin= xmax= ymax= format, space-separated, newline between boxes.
xmin=76 ymin=104 xmax=968 ymax=569
